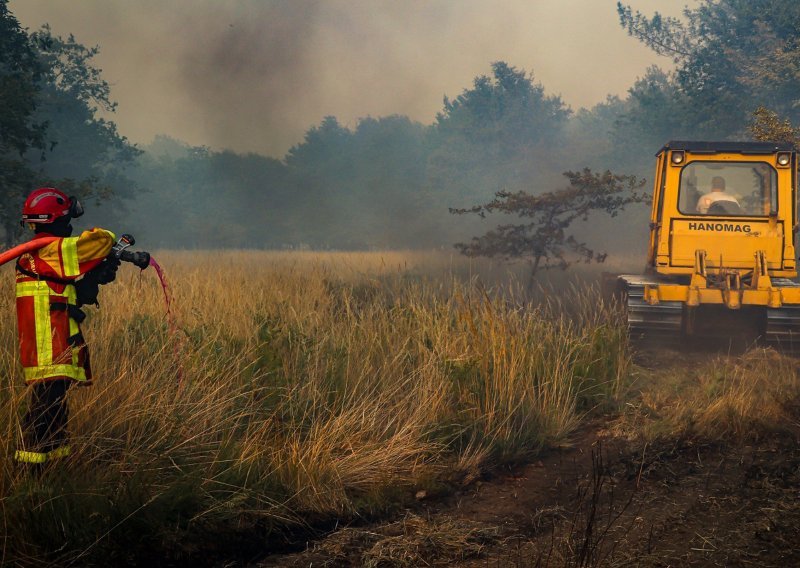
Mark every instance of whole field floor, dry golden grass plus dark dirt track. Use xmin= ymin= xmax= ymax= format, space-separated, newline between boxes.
xmin=0 ymin=251 xmax=800 ymax=566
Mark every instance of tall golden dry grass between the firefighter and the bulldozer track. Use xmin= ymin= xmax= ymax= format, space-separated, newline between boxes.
xmin=0 ymin=252 xmax=628 ymax=565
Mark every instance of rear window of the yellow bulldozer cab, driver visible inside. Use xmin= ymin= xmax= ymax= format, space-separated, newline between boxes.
xmin=678 ymin=161 xmax=778 ymax=216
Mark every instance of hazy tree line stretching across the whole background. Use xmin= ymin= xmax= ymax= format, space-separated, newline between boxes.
xmin=0 ymin=0 xmax=800 ymax=265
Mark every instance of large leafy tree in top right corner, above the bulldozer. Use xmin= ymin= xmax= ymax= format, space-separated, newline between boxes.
xmin=617 ymin=0 xmax=800 ymax=137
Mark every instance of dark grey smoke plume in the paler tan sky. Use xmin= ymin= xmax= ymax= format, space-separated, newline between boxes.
xmin=176 ymin=0 xmax=320 ymax=153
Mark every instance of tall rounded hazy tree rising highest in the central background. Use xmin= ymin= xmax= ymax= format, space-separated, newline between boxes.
xmin=428 ymin=61 xmax=571 ymax=211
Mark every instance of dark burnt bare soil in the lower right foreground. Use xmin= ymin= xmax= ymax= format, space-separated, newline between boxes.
xmin=255 ymin=352 xmax=800 ymax=567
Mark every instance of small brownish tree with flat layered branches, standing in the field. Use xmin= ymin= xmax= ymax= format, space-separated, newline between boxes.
xmin=450 ymin=168 xmax=648 ymax=283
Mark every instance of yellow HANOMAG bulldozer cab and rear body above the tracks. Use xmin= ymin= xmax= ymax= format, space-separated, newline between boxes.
xmin=648 ymin=141 xmax=797 ymax=278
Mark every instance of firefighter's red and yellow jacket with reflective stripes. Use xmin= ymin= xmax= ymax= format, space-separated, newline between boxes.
xmin=17 ymin=229 xmax=115 ymax=384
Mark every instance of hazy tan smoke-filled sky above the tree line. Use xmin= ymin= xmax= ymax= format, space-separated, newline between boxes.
xmin=9 ymin=0 xmax=696 ymax=157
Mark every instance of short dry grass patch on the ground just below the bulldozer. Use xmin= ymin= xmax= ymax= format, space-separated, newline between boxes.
xmin=614 ymin=347 xmax=800 ymax=443
